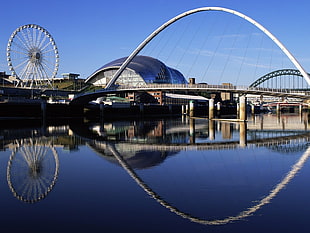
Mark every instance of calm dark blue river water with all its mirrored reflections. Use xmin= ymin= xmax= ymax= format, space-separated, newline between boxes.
xmin=0 ymin=114 xmax=310 ymax=232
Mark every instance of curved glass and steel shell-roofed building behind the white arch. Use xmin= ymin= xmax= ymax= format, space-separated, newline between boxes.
xmin=86 ymin=56 xmax=187 ymax=86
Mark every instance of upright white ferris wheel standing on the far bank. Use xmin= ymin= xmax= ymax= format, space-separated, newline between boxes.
xmin=7 ymin=24 xmax=59 ymax=88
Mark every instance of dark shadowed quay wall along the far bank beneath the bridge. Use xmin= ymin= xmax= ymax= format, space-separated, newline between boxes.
xmin=0 ymin=100 xmax=240 ymax=120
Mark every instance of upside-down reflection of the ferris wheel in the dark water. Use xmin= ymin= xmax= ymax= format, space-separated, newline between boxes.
xmin=7 ymin=139 xmax=59 ymax=203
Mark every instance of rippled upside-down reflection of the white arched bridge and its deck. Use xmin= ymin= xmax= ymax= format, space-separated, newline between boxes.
xmin=78 ymin=115 xmax=310 ymax=225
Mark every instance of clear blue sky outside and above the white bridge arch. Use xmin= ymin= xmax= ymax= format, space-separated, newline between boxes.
xmin=0 ymin=0 xmax=310 ymax=84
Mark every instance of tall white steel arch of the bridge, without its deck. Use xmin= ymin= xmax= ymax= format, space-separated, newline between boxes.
xmin=106 ymin=7 xmax=310 ymax=88
